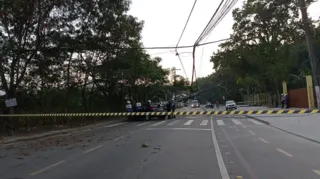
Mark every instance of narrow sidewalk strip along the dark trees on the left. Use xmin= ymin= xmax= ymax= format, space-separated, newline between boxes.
xmin=0 ymin=117 xmax=127 ymax=146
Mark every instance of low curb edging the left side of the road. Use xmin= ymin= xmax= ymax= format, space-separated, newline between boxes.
xmin=0 ymin=119 xmax=128 ymax=146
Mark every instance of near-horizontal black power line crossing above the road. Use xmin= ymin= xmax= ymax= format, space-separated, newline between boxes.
xmin=6 ymin=38 xmax=230 ymax=52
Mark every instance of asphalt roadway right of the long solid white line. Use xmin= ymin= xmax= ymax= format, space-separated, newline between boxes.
xmin=215 ymin=117 xmax=320 ymax=179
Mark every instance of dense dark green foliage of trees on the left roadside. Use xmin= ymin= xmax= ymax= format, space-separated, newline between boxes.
xmin=0 ymin=0 xmax=168 ymax=112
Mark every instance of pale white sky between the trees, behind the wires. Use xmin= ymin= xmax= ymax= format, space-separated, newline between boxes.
xmin=129 ymin=0 xmax=320 ymax=80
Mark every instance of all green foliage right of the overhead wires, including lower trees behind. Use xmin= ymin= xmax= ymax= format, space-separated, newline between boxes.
xmin=196 ymin=0 xmax=320 ymax=103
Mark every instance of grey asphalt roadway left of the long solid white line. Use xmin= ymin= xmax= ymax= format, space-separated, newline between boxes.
xmin=0 ymin=116 xmax=225 ymax=179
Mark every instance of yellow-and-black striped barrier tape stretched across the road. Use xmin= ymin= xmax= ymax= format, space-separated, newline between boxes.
xmin=0 ymin=109 xmax=320 ymax=117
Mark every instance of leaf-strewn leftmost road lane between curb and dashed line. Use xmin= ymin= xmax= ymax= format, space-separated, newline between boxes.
xmin=0 ymin=122 xmax=146 ymax=178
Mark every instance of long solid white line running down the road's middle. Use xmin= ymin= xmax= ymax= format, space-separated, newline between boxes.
xmin=210 ymin=120 xmax=230 ymax=179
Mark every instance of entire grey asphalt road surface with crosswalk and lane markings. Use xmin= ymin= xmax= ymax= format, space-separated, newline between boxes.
xmin=0 ymin=107 xmax=320 ymax=179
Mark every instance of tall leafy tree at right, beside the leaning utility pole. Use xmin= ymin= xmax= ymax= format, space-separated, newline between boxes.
xmin=206 ymin=0 xmax=312 ymax=106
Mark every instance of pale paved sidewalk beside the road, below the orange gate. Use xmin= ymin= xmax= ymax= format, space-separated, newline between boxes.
xmin=248 ymin=113 xmax=320 ymax=143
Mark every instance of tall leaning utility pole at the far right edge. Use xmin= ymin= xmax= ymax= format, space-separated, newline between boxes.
xmin=298 ymin=0 xmax=320 ymax=109
